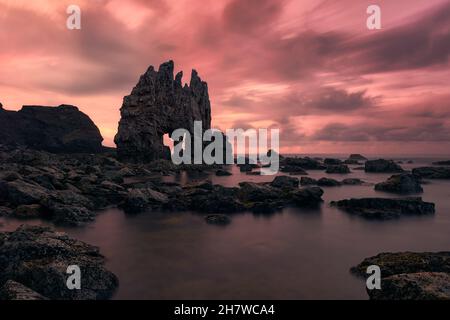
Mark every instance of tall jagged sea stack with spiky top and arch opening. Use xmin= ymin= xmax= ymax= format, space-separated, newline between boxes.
xmin=114 ymin=61 xmax=211 ymax=162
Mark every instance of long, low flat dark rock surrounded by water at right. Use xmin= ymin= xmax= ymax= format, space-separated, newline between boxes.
xmin=331 ymin=198 xmax=435 ymax=219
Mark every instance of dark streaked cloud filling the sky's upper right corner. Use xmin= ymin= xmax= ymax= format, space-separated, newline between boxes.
xmin=344 ymin=2 xmax=450 ymax=73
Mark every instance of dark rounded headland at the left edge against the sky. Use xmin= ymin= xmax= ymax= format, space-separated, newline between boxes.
xmin=0 ymin=105 xmax=103 ymax=153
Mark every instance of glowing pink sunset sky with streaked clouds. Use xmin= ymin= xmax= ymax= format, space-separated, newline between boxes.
xmin=0 ymin=0 xmax=450 ymax=154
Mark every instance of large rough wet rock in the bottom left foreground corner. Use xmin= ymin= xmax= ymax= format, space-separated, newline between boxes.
xmin=0 ymin=226 xmax=118 ymax=300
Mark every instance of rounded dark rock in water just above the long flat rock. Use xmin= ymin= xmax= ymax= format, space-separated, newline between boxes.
xmin=375 ymin=173 xmax=423 ymax=194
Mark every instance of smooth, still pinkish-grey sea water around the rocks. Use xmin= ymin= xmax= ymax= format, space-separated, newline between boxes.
xmin=0 ymin=159 xmax=450 ymax=299
